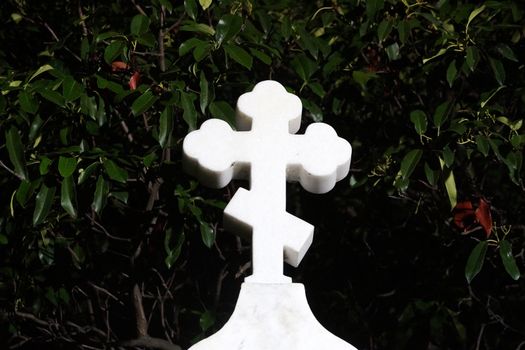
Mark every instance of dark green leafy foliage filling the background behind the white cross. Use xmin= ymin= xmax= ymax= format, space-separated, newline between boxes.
xmin=0 ymin=0 xmax=525 ymax=349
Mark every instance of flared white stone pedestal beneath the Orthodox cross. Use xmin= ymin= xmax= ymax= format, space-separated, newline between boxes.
xmin=190 ymin=283 xmax=356 ymax=350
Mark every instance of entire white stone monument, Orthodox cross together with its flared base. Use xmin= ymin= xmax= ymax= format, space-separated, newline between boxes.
xmin=183 ymin=80 xmax=355 ymax=350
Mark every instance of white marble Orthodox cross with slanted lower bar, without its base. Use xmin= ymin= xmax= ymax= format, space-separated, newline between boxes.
xmin=183 ymin=80 xmax=352 ymax=283
